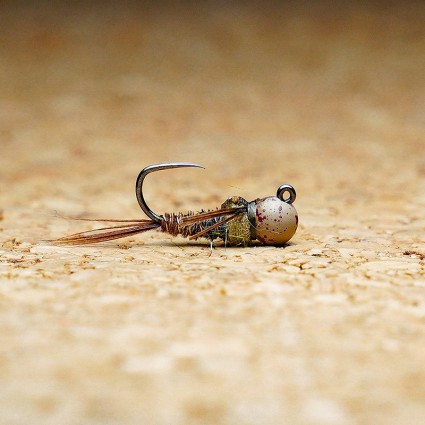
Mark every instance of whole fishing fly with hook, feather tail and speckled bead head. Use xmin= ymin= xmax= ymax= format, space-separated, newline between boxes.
xmin=55 ymin=162 xmax=298 ymax=246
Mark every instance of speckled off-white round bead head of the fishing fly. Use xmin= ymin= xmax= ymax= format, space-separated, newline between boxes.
xmin=256 ymin=196 xmax=298 ymax=245
